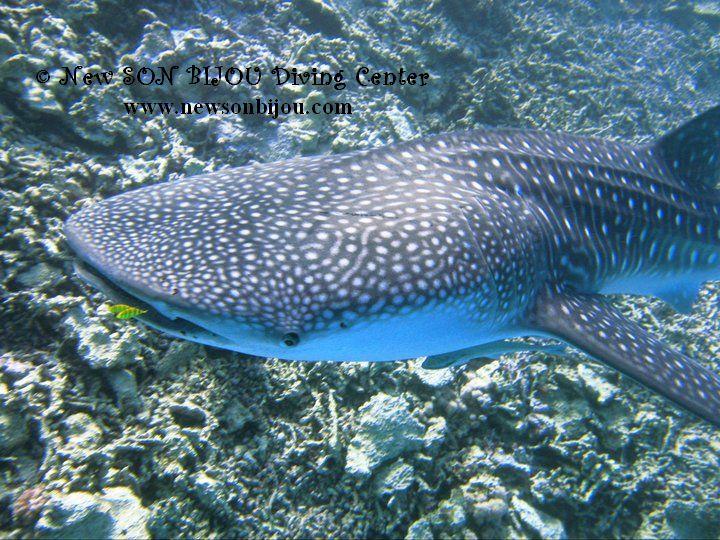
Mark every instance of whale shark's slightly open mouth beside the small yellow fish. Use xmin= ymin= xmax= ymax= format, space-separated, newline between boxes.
xmin=74 ymin=260 xmax=230 ymax=348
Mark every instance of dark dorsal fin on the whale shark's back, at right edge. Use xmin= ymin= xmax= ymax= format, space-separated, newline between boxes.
xmin=655 ymin=105 xmax=720 ymax=188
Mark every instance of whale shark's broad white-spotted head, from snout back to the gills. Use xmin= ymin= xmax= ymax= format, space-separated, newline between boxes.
xmin=66 ymin=153 xmax=507 ymax=360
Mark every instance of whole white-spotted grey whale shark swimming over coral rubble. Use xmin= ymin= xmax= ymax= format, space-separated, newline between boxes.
xmin=65 ymin=107 xmax=720 ymax=425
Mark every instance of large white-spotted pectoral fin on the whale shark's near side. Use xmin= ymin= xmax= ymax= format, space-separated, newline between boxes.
xmin=529 ymin=291 xmax=720 ymax=426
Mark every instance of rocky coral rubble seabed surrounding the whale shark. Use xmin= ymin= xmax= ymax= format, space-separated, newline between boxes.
xmin=0 ymin=0 xmax=720 ymax=538
